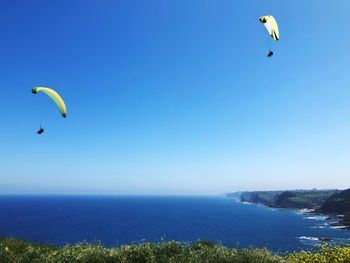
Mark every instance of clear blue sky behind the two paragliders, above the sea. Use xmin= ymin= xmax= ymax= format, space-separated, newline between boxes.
xmin=0 ymin=0 xmax=350 ymax=194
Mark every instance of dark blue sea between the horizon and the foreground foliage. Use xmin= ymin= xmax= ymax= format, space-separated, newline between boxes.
xmin=0 ymin=196 xmax=350 ymax=251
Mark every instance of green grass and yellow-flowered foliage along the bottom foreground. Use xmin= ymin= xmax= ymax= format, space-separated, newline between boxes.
xmin=0 ymin=239 xmax=350 ymax=263
